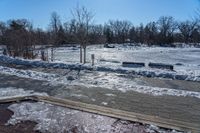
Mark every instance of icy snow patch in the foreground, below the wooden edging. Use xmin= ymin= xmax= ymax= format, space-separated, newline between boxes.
xmin=7 ymin=102 xmax=183 ymax=133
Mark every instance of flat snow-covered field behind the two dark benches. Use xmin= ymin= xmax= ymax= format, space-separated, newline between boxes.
xmin=45 ymin=44 xmax=200 ymax=80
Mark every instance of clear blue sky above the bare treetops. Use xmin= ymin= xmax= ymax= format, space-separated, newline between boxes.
xmin=0 ymin=0 xmax=200 ymax=28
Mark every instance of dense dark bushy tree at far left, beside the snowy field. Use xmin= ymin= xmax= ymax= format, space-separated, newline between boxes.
xmin=4 ymin=19 xmax=34 ymax=58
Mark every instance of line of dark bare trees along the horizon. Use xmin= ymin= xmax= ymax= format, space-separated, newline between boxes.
xmin=0 ymin=6 xmax=200 ymax=60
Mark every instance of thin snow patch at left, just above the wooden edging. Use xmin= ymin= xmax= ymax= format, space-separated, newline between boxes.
xmin=0 ymin=87 xmax=47 ymax=99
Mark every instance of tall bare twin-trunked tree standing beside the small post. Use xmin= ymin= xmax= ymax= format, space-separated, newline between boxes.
xmin=72 ymin=6 xmax=94 ymax=63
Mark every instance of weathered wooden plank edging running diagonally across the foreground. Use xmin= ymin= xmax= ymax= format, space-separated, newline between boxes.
xmin=0 ymin=95 xmax=200 ymax=133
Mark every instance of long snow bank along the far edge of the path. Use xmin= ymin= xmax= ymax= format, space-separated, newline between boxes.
xmin=0 ymin=56 xmax=200 ymax=81
